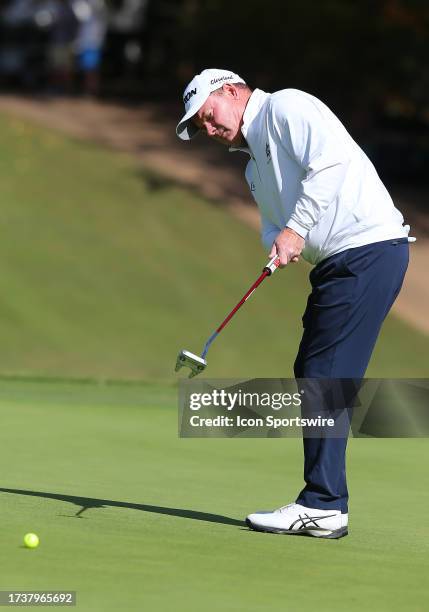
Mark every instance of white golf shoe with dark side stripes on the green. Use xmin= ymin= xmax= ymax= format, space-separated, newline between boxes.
xmin=246 ymin=504 xmax=348 ymax=539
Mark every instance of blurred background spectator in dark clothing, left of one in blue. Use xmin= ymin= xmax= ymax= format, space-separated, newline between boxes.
xmin=48 ymin=0 xmax=78 ymax=94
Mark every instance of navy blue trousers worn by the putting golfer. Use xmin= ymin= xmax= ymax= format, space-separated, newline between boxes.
xmin=294 ymin=238 xmax=408 ymax=513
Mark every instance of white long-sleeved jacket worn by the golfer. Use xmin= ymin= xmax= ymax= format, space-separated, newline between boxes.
xmin=231 ymin=89 xmax=410 ymax=264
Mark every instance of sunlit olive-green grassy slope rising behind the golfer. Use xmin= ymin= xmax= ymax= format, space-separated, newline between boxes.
xmin=0 ymin=110 xmax=429 ymax=380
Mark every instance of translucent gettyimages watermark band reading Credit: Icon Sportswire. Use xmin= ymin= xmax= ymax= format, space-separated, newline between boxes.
xmin=179 ymin=378 xmax=429 ymax=438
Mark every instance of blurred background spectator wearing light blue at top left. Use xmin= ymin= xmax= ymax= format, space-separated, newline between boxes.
xmin=74 ymin=0 xmax=108 ymax=96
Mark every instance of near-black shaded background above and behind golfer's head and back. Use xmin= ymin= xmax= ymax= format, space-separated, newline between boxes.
xmin=0 ymin=0 xmax=429 ymax=184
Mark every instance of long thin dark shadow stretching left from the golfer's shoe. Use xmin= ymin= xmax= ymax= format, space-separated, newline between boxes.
xmin=0 ymin=488 xmax=244 ymax=527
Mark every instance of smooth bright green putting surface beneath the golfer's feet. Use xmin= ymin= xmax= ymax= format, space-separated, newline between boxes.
xmin=0 ymin=380 xmax=429 ymax=612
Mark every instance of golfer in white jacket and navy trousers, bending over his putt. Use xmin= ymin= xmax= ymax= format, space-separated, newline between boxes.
xmin=176 ymin=69 xmax=414 ymax=538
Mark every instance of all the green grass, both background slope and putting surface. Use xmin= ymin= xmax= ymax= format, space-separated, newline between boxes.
xmin=0 ymin=107 xmax=429 ymax=612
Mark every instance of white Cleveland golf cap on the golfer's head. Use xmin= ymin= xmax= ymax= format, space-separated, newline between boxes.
xmin=176 ymin=68 xmax=245 ymax=140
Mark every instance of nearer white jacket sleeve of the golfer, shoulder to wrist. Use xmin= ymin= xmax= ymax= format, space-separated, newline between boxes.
xmin=268 ymin=94 xmax=349 ymax=238
